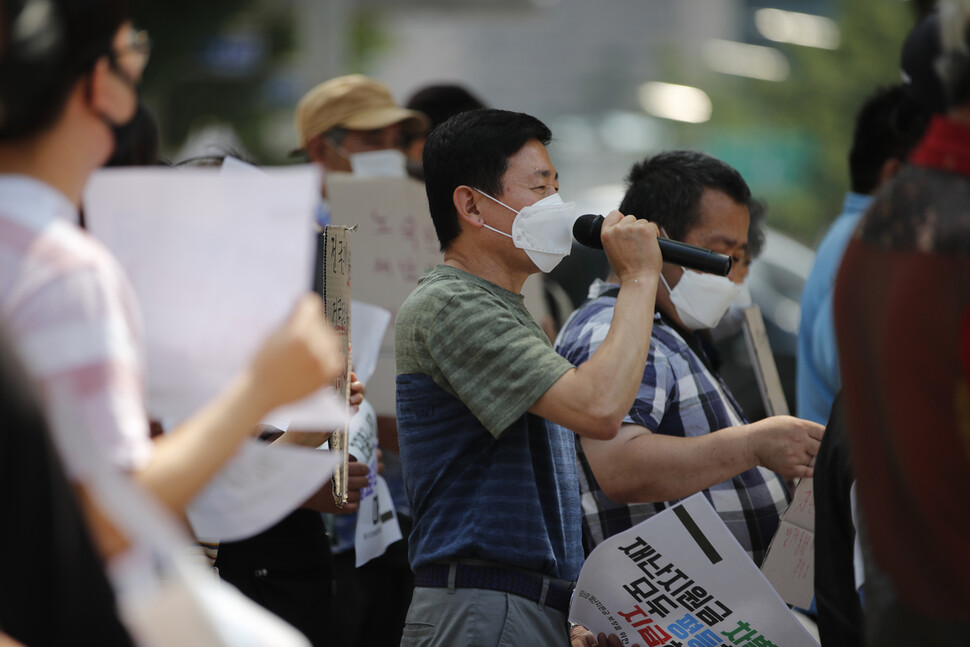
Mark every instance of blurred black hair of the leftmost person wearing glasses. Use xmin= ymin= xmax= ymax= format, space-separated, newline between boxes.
xmin=0 ymin=0 xmax=128 ymax=142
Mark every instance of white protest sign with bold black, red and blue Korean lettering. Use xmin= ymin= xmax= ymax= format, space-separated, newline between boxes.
xmin=569 ymin=494 xmax=818 ymax=647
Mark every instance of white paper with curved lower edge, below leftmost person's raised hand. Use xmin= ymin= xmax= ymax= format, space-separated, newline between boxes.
xmin=186 ymin=440 xmax=340 ymax=541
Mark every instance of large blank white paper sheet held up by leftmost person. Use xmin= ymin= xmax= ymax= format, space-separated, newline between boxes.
xmin=84 ymin=166 xmax=320 ymax=422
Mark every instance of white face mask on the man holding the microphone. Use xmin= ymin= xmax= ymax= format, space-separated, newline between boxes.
xmin=475 ymin=189 xmax=576 ymax=273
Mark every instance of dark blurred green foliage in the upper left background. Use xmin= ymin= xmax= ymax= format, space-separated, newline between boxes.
xmin=126 ymin=0 xmax=391 ymax=163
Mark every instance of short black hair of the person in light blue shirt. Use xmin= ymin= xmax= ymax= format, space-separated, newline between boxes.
xmin=849 ymin=85 xmax=929 ymax=194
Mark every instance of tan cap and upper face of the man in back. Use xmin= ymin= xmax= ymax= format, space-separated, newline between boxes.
xmin=294 ymin=74 xmax=430 ymax=205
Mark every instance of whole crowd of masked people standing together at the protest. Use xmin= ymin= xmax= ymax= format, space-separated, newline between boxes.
xmin=0 ymin=0 xmax=970 ymax=647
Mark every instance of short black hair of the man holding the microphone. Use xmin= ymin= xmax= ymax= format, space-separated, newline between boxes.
xmin=423 ymin=109 xmax=552 ymax=251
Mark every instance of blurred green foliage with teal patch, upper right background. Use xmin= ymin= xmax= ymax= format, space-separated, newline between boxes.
xmin=695 ymin=0 xmax=916 ymax=245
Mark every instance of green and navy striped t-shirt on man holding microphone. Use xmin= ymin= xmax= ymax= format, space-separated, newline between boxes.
xmin=395 ymin=265 xmax=583 ymax=581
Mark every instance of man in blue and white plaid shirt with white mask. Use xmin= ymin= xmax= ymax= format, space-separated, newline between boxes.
xmin=556 ymin=151 xmax=823 ymax=564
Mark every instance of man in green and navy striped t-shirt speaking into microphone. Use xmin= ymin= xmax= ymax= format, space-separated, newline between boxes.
xmin=395 ymin=110 xmax=661 ymax=647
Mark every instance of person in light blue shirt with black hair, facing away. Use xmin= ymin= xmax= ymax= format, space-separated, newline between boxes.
xmin=795 ymin=85 xmax=926 ymax=424
